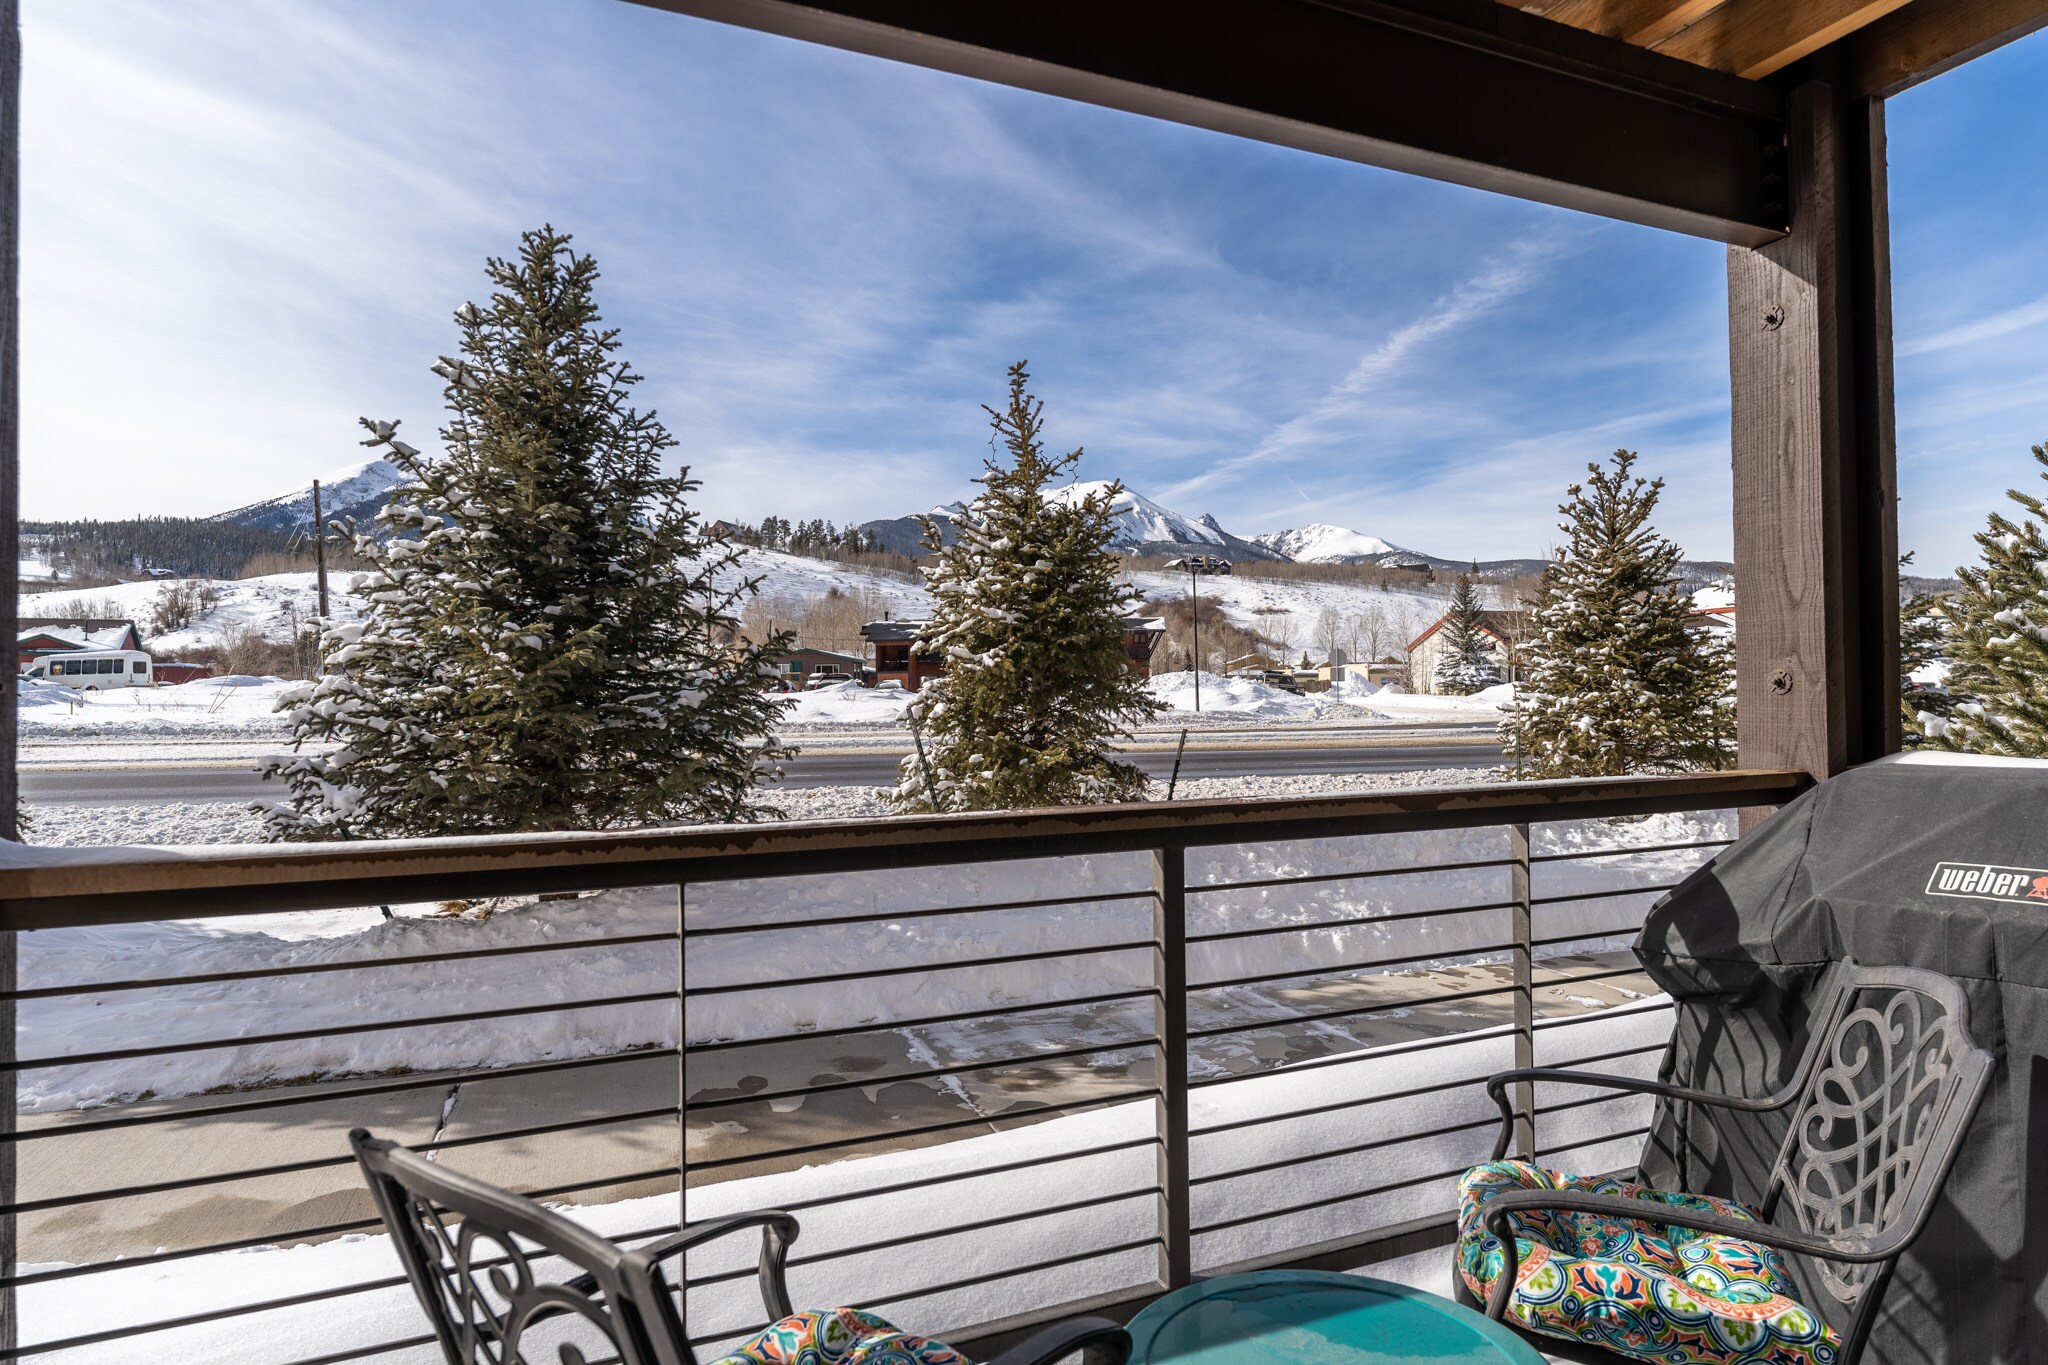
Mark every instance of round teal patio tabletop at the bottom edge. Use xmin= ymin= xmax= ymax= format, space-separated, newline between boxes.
xmin=1130 ymin=1271 xmax=1544 ymax=1365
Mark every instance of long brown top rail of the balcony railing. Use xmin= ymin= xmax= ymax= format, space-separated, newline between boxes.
xmin=0 ymin=772 xmax=1810 ymax=929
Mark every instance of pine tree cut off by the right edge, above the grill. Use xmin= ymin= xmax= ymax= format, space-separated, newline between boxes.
xmin=1921 ymin=446 xmax=2048 ymax=757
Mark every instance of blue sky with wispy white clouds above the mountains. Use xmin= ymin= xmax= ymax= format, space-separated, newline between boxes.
xmin=23 ymin=0 xmax=2048 ymax=569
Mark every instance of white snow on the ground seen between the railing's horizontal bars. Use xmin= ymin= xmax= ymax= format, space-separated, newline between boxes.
xmin=18 ymin=817 xmax=1703 ymax=1365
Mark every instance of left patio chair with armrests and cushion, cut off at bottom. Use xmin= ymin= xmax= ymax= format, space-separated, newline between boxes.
xmin=348 ymin=1128 xmax=1130 ymax=1365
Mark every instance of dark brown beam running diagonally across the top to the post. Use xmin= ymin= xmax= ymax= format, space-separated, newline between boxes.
xmin=637 ymin=0 xmax=1786 ymax=246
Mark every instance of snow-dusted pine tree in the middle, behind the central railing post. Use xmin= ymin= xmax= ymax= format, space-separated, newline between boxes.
xmin=897 ymin=360 xmax=1159 ymax=810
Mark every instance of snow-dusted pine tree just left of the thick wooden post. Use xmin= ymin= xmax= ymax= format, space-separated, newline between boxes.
xmin=1501 ymin=450 xmax=1735 ymax=778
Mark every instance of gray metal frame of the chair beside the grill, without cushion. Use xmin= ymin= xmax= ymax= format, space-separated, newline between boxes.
xmin=1487 ymin=962 xmax=1993 ymax=1365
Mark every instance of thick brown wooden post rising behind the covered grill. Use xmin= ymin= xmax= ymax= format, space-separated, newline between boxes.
xmin=1729 ymin=69 xmax=1901 ymax=778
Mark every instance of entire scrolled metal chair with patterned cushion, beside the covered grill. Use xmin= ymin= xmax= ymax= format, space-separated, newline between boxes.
xmin=1456 ymin=962 xmax=1993 ymax=1365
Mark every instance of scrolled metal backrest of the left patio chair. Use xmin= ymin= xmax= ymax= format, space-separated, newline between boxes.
xmin=348 ymin=1128 xmax=688 ymax=1365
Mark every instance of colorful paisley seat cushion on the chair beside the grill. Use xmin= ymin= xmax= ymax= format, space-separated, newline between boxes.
xmin=1458 ymin=1160 xmax=1841 ymax=1365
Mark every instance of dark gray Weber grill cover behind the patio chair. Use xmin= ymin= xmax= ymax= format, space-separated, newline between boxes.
xmin=1636 ymin=755 xmax=2048 ymax=1365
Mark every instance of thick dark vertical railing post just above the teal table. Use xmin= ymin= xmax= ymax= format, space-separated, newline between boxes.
xmin=1153 ymin=849 xmax=1194 ymax=1289
